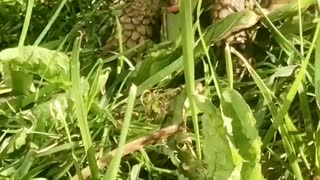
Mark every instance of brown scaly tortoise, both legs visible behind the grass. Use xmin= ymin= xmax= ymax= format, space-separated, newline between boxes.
xmin=101 ymin=0 xmax=290 ymax=56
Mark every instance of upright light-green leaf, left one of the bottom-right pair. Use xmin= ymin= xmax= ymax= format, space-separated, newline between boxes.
xmin=195 ymin=96 xmax=243 ymax=180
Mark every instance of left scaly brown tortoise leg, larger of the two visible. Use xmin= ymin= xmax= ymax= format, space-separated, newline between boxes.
xmin=101 ymin=0 xmax=168 ymax=56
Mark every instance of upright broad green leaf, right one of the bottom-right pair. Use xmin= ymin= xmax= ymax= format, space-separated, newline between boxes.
xmin=221 ymin=89 xmax=263 ymax=180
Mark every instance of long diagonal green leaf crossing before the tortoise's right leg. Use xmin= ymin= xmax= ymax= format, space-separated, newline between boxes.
xmin=134 ymin=11 xmax=259 ymax=94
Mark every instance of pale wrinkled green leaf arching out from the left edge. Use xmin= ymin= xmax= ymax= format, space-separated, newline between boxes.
xmin=0 ymin=46 xmax=69 ymax=85
